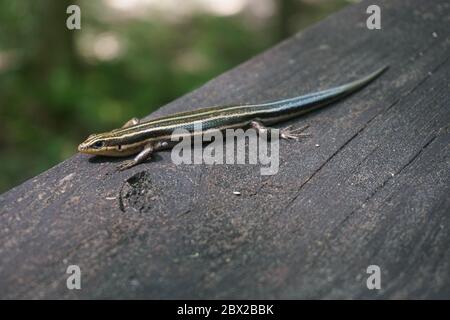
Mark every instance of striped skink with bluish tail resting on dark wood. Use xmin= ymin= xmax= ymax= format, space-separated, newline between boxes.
xmin=78 ymin=66 xmax=388 ymax=170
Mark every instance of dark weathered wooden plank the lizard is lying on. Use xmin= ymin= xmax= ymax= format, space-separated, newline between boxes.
xmin=0 ymin=0 xmax=450 ymax=299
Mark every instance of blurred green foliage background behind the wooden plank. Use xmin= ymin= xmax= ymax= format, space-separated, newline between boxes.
xmin=0 ymin=0 xmax=356 ymax=192
